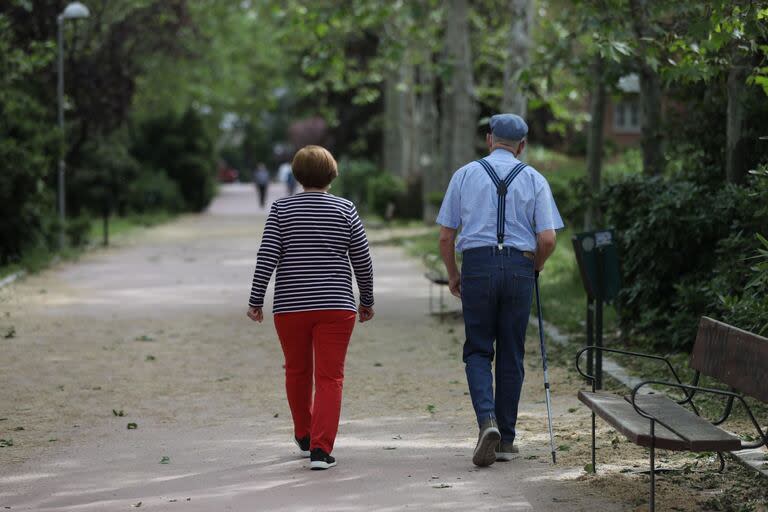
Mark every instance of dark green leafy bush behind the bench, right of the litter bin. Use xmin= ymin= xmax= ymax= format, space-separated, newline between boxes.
xmin=601 ymin=166 xmax=768 ymax=349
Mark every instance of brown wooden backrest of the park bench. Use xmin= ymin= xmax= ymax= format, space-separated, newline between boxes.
xmin=691 ymin=316 xmax=768 ymax=402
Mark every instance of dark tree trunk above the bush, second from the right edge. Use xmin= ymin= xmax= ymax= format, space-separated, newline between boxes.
xmin=629 ymin=0 xmax=664 ymax=176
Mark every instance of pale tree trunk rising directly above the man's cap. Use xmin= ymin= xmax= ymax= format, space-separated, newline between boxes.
xmin=501 ymin=0 xmax=533 ymax=117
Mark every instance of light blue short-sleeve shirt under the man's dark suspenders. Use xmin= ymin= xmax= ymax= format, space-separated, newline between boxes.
xmin=437 ymin=149 xmax=564 ymax=252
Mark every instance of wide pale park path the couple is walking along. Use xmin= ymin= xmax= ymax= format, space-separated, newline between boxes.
xmin=0 ymin=185 xmax=632 ymax=512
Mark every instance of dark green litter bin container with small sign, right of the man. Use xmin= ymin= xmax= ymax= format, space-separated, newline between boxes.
xmin=573 ymin=229 xmax=621 ymax=302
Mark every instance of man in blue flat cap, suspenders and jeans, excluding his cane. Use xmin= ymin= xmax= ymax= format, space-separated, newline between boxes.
xmin=437 ymin=114 xmax=563 ymax=466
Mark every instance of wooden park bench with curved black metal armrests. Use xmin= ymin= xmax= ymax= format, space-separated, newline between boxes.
xmin=576 ymin=317 xmax=768 ymax=511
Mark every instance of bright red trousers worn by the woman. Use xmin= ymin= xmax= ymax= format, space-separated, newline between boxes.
xmin=275 ymin=310 xmax=356 ymax=453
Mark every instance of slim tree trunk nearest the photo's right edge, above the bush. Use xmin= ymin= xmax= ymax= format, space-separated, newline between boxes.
xmin=725 ymin=59 xmax=750 ymax=183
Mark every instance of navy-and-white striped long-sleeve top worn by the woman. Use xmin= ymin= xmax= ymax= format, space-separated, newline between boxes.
xmin=248 ymin=192 xmax=373 ymax=313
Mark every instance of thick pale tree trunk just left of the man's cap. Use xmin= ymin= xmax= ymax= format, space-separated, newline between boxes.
xmin=440 ymin=0 xmax=477 ymax=182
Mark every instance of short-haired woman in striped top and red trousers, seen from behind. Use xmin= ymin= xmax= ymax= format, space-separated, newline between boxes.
xmin=248 ymin=146 xmax=373 ymax=469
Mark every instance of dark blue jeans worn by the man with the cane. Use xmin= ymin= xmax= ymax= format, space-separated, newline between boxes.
xmin=461 ymin=247 xmax=534 ymax=443
